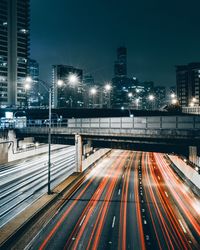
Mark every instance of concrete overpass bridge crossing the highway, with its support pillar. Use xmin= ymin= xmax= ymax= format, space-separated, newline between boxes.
xmin=15 ymin=116 xmax=200 ymax=169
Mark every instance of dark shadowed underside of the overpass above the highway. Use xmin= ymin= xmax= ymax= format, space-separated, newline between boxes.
xmin=20 ymin=134 xmax=194 ymax=156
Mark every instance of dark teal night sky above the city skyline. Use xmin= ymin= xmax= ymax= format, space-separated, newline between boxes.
xmin=31 ymin=0 xmax=200 ymax=86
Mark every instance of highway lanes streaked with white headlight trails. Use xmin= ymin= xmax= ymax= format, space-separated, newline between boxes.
xmin=0 ymin=146 xmax=75 ymax=227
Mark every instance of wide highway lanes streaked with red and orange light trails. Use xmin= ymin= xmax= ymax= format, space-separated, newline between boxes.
xmin=26 ymin=150 xmax=200 ymax=250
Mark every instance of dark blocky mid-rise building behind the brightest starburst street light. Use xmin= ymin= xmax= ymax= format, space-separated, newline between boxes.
xmin=52 ymin=65 xmax=84 ymax=108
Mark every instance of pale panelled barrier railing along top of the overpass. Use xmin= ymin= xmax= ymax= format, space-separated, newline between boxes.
xmin=22 ymin=116 xmax=200 ymax=130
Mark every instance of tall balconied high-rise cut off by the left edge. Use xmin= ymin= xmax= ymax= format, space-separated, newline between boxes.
xmin=0 ymin=0 xmax=30 ymax=106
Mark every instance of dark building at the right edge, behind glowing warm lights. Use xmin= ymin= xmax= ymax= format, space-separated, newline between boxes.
xmin=176 ymin=63 xmax=200 ymax=107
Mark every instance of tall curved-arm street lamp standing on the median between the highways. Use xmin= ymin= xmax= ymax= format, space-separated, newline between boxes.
xmin=25 ymin=77 xmax=52 ymax=194
